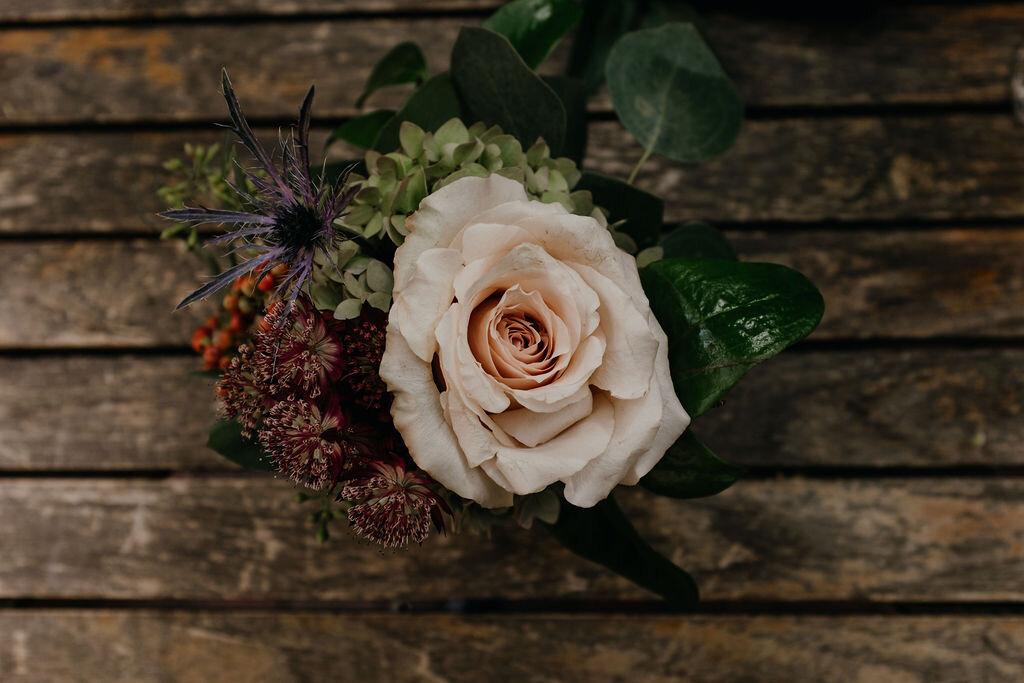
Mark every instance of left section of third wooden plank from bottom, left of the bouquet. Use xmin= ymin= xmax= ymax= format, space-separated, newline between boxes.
xmin=0 ymin=355 xmax=224 ymax=470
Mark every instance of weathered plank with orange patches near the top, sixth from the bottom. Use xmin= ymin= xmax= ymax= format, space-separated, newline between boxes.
xmin=0 ymin=0 xmax=1024 ymax=124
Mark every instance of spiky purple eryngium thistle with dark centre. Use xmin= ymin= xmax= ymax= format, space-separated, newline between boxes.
xmin=160 ymin=70 xmax=358 ymax=308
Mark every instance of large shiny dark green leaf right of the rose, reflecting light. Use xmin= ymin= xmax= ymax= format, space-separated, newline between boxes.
xmin=640 ymin=259 xmax=824 ymax=417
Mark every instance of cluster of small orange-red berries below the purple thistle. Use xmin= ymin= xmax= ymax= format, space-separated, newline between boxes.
xmin=191 ymin=264 xmax=288 ymax=370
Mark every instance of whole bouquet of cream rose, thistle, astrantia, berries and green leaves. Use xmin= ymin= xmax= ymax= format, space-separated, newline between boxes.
xmin=161 ymin=0 xmax=823 ymax=603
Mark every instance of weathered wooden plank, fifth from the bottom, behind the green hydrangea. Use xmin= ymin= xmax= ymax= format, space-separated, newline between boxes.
xmin=8 ymin=115 xmax=1024 ymax=234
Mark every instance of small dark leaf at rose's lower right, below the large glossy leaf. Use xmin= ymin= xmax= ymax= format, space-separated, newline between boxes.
xmin=640 ymin=429 xmax=743 ymax=498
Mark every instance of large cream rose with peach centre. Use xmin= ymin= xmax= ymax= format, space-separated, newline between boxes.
xmin=381 ymin=175 xmax=689 ymax=508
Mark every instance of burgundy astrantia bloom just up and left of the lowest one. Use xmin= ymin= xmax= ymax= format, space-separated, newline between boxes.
xmin=259 ymin=396 xmax=376 ymax=489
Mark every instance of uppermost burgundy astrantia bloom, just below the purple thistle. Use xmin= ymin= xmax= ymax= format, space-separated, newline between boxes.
xmin=254 ymin=296 xmax=344 ymax=398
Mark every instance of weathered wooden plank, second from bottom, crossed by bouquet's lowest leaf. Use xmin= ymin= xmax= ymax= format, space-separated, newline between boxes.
xmin=0 ymin=477 xmax=1024 ymax=602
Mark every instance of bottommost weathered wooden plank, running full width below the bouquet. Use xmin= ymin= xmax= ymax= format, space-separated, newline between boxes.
xmin=0 ymin=609 xmax=1024 ymax=683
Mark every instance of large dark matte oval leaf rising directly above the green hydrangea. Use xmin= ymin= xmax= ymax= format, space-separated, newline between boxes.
xmin=452 ymin=28 xmax=565 ymax=153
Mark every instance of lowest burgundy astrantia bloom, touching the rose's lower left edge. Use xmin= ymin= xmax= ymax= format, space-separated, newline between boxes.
xmin=340 ymin=459 xmax=449 ymax=548
